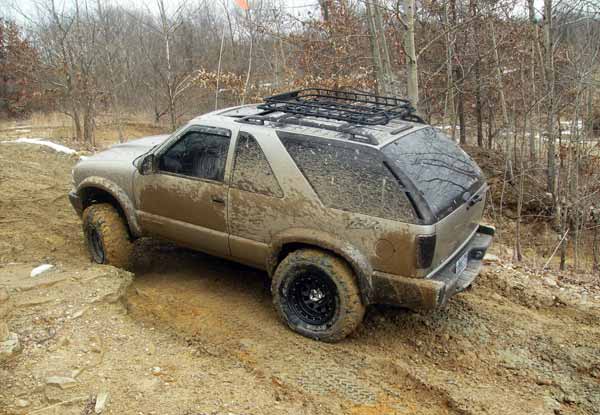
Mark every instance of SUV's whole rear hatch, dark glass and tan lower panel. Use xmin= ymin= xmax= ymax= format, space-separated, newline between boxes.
xmin=382 ymin=127 xmax=486 ymax=269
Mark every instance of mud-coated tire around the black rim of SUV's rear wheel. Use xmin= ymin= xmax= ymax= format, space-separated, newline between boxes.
xmin=271 ymin=249 xmax=365 ymax=343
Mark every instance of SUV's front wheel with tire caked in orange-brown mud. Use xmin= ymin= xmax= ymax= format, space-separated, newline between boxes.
xmin=83 ymin=203 xmax=133 ymax=269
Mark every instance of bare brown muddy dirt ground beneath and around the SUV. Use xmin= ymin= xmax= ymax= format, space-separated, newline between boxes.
xmin=0 ymin=144 xmax=600 ymax=415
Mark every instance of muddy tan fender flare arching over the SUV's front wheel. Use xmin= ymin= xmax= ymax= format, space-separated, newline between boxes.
xmin=77 ymin=177 xmax=141 ymax=238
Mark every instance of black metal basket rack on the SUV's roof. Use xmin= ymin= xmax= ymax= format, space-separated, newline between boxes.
xmin=258 ymin=88 xmax=423 ymax=125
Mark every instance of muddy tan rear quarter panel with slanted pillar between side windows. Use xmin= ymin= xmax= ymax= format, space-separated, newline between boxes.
xmin=229 ymin=125 xmax=435 ymax=276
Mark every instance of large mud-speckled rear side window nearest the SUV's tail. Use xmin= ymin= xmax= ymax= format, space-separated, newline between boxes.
xmin=281 ymin=135 xmax=415 ymax=221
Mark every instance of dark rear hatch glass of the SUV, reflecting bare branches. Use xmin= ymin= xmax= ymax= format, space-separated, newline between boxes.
xmin=383 ymin=128 xmax=483 ymax=216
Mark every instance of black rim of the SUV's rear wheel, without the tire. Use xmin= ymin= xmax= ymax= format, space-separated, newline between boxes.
xmin=287 ymin=270 xmax=338 ymax=326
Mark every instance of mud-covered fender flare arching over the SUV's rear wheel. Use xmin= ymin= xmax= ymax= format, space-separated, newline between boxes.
xmin=266 ymin=228 xmax=373 ymax=305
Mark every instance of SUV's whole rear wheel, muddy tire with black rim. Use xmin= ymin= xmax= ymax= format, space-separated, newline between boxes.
xmin=271 ymin=249 xmax=365 ymax=342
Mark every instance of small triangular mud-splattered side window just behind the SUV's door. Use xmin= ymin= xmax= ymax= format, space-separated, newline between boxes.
xmin=232 ymin=132 xmax=283 ymax=197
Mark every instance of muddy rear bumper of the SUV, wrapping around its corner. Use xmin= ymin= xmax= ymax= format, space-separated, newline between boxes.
xmin=371 ymin=225 xmax=495 ymax=310
